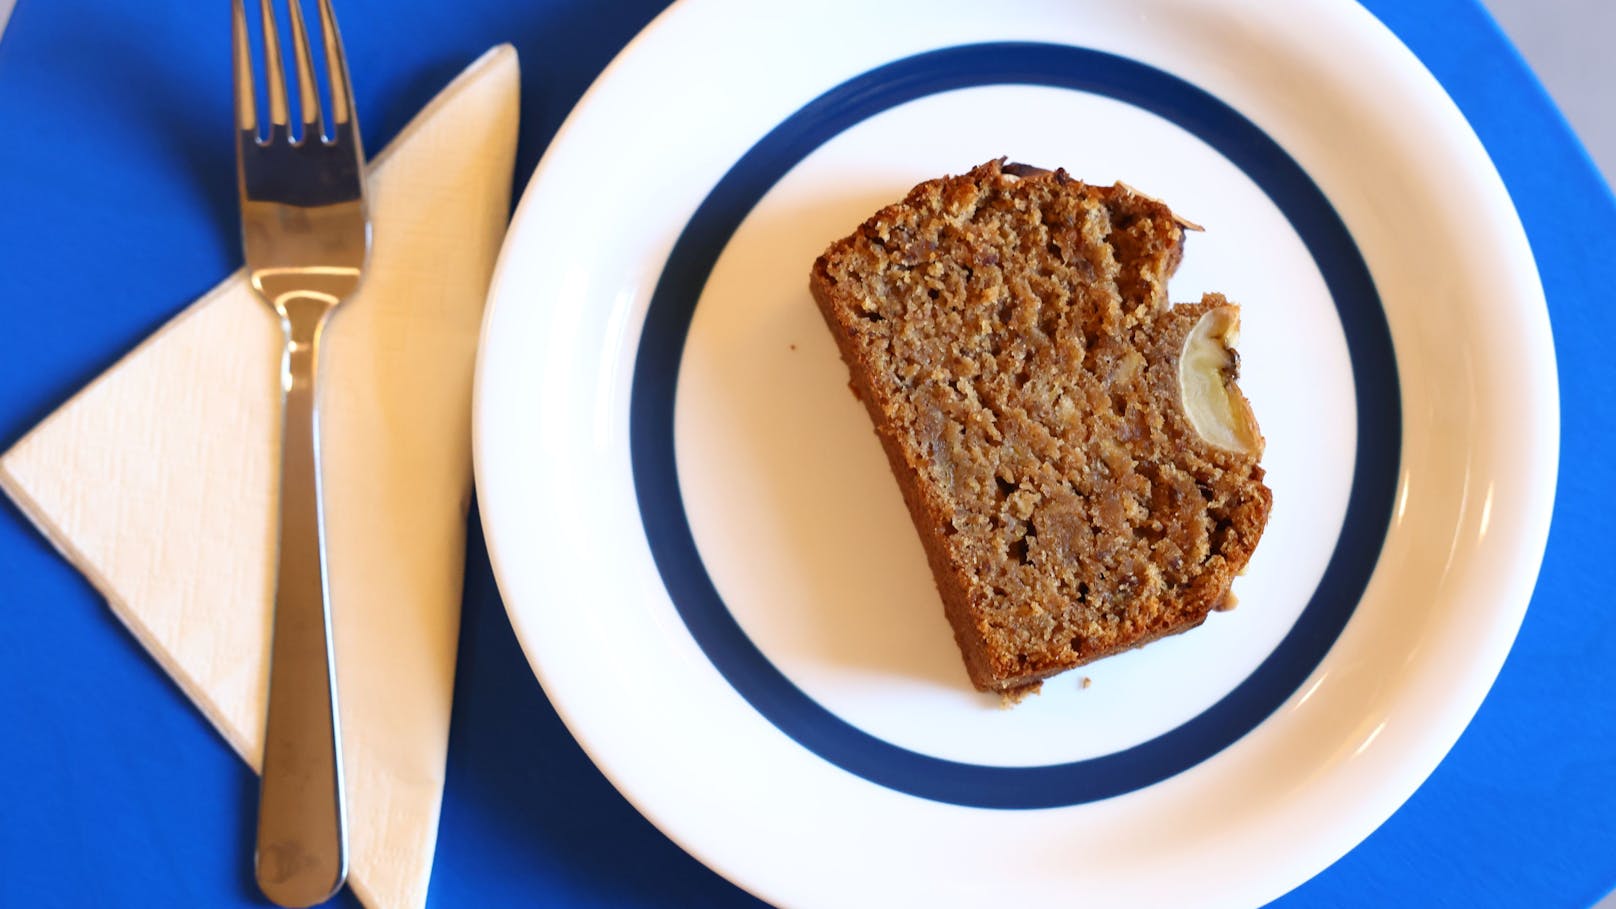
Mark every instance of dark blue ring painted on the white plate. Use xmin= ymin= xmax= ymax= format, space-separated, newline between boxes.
xmin=629 ymin=42 xmax=1401 ymax=809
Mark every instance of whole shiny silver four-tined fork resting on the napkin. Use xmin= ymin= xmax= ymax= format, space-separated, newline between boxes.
xmin=233 ymin=0 xmax=370 ymax=906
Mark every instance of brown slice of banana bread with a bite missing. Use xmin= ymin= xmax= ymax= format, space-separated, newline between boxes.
xmin=810 ymin=160 xmax=1272 ymax=695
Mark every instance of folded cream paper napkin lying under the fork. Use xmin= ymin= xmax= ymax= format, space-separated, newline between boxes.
xmin=0 ymin=47 xmax=517 ymax=907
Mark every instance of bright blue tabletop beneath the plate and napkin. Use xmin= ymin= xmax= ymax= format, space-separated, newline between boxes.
xmin=0 ymin=0 xmax=1616 ymax=907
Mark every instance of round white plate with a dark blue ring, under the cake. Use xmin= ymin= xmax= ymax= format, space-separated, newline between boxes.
xmin=475 ymin=0 xmax=1558 ymax=907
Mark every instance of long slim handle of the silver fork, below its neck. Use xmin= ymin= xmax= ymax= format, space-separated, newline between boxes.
xmin=255 ymin=301 xmax=347 ymax=906
